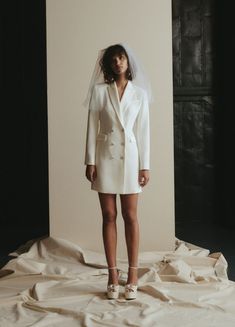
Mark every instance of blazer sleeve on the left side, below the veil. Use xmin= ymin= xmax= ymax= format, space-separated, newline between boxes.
xmin=84 ymin=86 xmax=100 ymax=165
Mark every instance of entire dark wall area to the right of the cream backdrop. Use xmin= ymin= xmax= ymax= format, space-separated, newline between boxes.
xmin=172 ymin=0 xmax=235 ymax=279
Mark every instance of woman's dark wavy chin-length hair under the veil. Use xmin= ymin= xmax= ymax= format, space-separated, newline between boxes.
xmin=99 ymin=44 xmax=133 ymax=84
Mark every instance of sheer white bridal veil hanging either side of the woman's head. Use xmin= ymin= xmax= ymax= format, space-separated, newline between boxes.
xmin=83 ymin=43 xmax=153 ymax=107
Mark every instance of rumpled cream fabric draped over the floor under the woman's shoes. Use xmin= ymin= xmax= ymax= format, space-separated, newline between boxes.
xmin=0 ymin=237 xmax=235 ymax=327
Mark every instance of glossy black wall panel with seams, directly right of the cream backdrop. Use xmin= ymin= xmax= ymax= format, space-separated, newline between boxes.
xmin=172 ymin=0 xmax=215 ymax=226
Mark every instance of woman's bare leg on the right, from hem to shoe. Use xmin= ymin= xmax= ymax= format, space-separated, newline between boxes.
xmin=120 ymin=193 xmax=139 ymax=284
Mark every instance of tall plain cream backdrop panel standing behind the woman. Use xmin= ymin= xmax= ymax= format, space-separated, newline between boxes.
xmin=46 ymin=0 xmax=175 ymax=259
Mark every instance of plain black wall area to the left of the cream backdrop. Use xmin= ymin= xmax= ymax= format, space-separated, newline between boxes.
xmin=0 ymin=0 xmax=49 ymax=253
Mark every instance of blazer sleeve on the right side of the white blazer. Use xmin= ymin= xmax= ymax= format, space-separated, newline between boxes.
xmin=136 ymin=92 xmax=150 ymax=170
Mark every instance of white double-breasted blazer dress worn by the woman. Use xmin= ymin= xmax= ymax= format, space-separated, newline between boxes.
xmin=85 ymin=81 xmax=150 ymax=194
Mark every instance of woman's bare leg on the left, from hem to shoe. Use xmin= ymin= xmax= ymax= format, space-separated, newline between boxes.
xmin=99 ymin=193 xmax=118 ymax=284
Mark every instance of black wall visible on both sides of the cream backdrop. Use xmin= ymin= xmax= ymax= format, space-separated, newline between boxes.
xmin=0 ymin=0 xmax=235 ymax=279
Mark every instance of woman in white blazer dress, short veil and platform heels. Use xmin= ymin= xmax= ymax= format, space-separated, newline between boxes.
xmin=85 ymin=44 xmax=150 ymax=299
